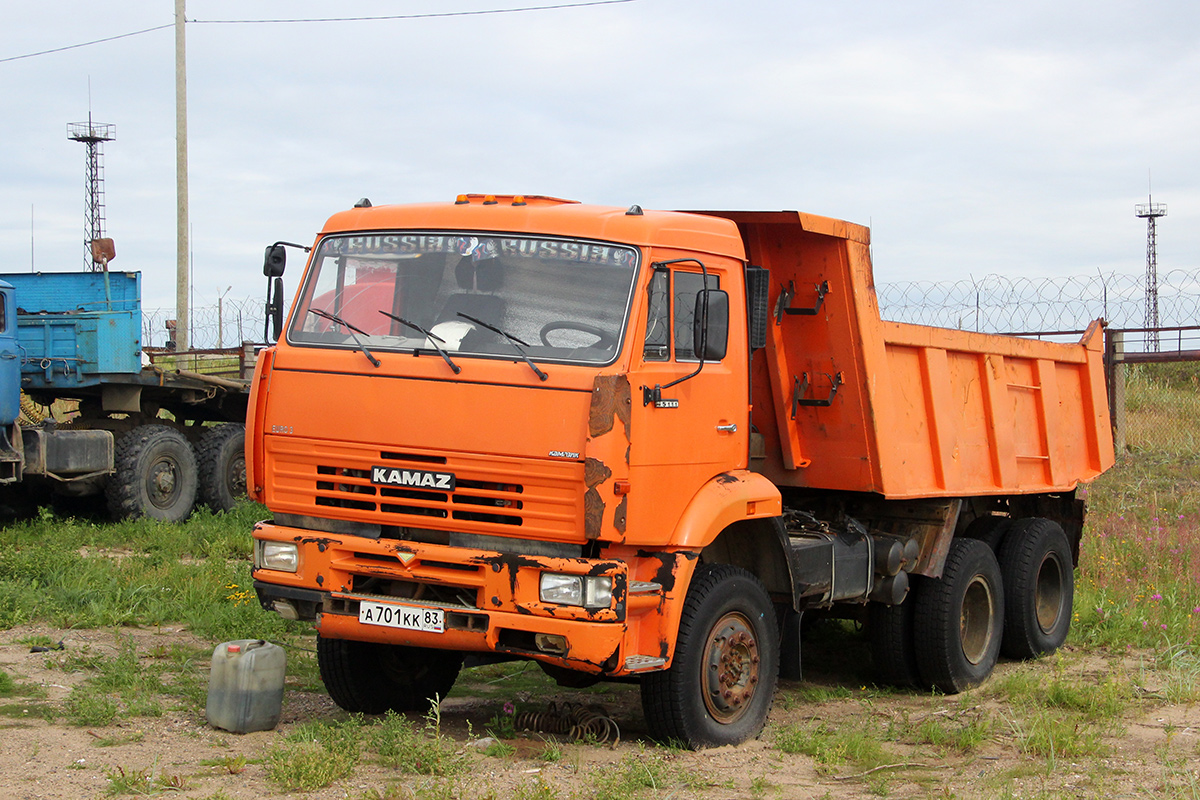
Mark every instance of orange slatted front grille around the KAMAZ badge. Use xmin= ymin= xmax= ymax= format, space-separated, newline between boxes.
xmin=268 ymin=438 xmax=583 ymax=541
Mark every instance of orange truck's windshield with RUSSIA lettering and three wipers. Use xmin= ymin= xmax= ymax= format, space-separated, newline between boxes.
xmin=288 ymin=233 xmax=637 ymax=363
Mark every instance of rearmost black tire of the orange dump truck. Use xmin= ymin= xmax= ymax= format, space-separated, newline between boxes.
xmin=1000 ymin=517 xmax=1075 ymax=658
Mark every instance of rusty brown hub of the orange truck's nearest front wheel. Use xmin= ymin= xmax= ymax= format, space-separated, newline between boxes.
xmin=704 ymin=613 xmax=761 ymax=723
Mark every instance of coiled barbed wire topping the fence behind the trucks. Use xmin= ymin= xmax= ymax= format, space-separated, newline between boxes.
xmin=142 ymin=270 xmax=1200 ymax=348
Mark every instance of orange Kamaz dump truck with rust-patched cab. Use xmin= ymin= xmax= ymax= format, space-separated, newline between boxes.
xmin=246 ymin=196 xmax=1114 ymax=747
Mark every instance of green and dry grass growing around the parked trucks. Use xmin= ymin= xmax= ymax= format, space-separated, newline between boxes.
xmin=0 ymin=372 xmax=1200 ymax=800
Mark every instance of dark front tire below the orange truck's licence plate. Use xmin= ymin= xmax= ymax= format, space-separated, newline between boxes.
xmin=317 ymin=637 xmax=462 ymax=714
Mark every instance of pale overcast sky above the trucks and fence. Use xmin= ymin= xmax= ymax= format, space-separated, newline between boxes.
xmin=0 ymin=0 xmax=1200 ymax=316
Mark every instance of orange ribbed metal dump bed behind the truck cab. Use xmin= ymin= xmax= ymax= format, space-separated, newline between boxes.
xmin=712 ymin=211 xmax=1114 ymax=498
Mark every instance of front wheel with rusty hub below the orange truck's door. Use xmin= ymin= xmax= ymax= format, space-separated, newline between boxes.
xmin=642 ymin=564 xmax=780 ymax=748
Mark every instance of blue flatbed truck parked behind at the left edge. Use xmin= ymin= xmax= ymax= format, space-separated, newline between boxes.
xmin=0 ymin=271 xmax=248 ymax=522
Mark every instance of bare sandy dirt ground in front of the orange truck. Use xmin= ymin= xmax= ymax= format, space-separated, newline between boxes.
xmin=0 ymin=626 xmax=1200 ymax=800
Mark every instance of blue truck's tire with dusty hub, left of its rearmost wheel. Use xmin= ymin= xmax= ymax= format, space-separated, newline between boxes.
xmin=104 ymin=425 xmax=197 ymax=522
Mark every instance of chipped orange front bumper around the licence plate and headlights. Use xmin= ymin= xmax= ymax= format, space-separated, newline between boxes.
xmin=254 ymin=523 xmax=668 ymax=675
